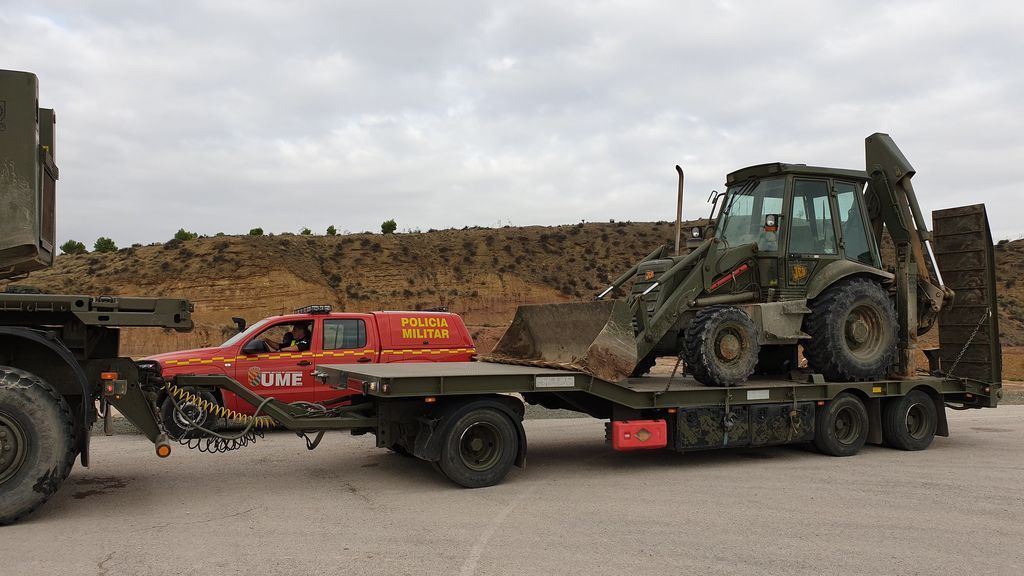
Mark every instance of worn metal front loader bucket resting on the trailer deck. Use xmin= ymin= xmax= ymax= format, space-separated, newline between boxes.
xmin=482 ymin=300 xmax=638 ymax=382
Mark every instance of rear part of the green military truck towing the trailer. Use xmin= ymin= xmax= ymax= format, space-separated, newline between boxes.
xmin=0 ymin=71 xmax=193 ymax=524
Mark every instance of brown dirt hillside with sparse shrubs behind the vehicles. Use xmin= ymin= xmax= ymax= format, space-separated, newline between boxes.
xmin=0 ymin=222 xmax=1024 ymax=379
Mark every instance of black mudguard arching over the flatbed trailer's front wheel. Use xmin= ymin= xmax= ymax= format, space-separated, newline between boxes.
xmin=413 ymin=396 xmax=526 ymax=468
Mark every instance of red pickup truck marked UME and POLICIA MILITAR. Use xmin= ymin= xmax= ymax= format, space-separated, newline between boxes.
xmin=138 ymin=305 xmax=476 ymax=436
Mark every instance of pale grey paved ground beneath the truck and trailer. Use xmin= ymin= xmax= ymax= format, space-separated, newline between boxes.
xmin=8 ymin=406 xmax=1024 ymax=576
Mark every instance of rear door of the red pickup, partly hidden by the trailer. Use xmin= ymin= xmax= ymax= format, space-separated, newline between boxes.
xmin=314 ymin=314 xmax=380 ymax=403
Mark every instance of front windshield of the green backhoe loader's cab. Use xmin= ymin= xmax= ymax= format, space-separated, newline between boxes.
xmin=717 ymin=176 xmax=785 ymax=252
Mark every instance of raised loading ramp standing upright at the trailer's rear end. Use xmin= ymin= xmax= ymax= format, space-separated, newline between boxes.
xmin=932 ymin=204 xmax=1002 ymax=399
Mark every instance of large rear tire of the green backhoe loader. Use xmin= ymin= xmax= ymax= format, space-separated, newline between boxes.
xmin=803 ymin=278 xmax=896 ymax=382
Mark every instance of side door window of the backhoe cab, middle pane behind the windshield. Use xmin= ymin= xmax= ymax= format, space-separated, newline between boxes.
xmin=790 ymin=179 xmax=838 ymax=254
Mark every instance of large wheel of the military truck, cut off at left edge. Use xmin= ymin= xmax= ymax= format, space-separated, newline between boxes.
xmin=0 ymin=366 xmax=78 ymax=526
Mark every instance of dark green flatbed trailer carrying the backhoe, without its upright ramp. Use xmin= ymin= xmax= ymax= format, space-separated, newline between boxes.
xmin=175 ymin=362 xmax=1001 ymax=488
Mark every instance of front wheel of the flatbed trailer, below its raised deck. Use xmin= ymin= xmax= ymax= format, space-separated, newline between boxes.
xmin=437 ymin=408 xmax=519 ymax=488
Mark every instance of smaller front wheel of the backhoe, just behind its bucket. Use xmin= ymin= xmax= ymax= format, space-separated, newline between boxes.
xmin=684 ymin=306 xmax=761 ymax=386
